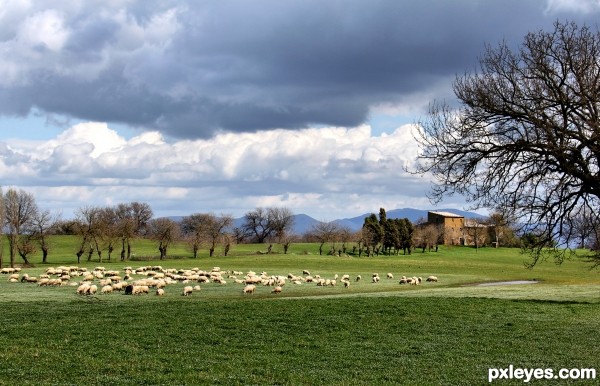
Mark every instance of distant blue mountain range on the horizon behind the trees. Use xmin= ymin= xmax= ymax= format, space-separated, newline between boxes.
xmin=224 ymin=208 xmax=483 ymax=235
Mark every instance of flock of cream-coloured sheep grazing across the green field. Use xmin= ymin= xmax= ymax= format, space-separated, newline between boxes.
xmin=0 ymin=266 xmax=438 ymax=296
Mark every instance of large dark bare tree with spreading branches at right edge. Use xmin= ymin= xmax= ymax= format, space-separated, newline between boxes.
xmin=415 ymin=22 xmax=600 ymax=264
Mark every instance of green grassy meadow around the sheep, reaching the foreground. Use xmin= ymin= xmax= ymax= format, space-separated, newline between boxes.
xmin=0 ymin=237 xmax=600 ymax=385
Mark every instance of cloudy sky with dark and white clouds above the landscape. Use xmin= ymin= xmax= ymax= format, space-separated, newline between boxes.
xmin=0 ymin=0 xmax=600 ymax=221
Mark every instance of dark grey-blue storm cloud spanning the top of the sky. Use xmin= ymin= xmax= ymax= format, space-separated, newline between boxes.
xmin=0 ymin=0 xmax=594 ymax=138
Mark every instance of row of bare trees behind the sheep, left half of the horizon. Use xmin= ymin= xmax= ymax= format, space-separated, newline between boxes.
xmin=0 ymin=188 xmax=294 ymax=266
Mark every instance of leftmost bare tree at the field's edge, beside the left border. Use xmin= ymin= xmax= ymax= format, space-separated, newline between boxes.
xmin=4 ymin=188 xmax=38 ymax=267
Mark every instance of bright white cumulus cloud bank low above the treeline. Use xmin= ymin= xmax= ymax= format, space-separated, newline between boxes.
xmin=0 ymin=122 xmax=454 ymax=219
